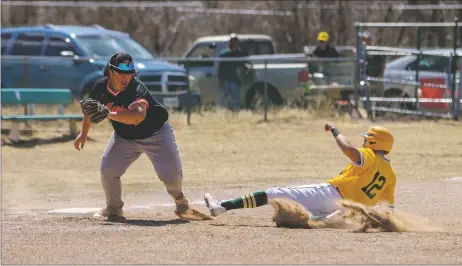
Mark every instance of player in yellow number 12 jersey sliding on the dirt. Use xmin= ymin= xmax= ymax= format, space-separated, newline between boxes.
xmin=204 ymin=122 xmax=396 ymax=218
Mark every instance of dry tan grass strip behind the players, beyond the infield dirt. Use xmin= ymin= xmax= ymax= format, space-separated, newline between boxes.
xmin=2 ymin=106 xmax=462 ymax=208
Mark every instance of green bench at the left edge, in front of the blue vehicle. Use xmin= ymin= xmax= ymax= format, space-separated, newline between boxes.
xmin=1 ymin=88 xmax=83 ymax=141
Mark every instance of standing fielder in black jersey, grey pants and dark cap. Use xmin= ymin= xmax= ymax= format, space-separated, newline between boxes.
xmin=74 ymin=53 xmax=210 ymax=220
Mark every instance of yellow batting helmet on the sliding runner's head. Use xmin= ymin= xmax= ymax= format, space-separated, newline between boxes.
xmin=361 ymin=126 xmax=394 ymax=154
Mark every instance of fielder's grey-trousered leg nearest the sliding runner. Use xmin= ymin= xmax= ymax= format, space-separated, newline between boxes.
xmin=138 ymin=122 xmax=189 ymax=215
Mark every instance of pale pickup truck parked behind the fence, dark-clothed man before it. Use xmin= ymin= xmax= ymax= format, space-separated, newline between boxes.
xmin=183 ymin=34 xmax=308 ymax=109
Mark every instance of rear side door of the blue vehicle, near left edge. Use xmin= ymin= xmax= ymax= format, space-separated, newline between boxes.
xmin=2 ymin=32 xmax=46 ymax=88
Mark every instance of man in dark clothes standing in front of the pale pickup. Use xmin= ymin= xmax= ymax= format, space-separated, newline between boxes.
xmin=218 ymin=34 xmax=248 ymax=112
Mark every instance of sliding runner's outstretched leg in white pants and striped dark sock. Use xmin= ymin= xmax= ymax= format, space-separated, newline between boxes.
xmin=204 ymin=184 xmax=342 ymax=216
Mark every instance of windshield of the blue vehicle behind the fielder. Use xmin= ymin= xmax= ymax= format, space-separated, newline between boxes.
xmin=76 ymin=35 xmax=153 ymax=60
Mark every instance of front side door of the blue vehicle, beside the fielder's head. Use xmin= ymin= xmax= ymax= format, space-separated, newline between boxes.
xmin=40 ymin=33 xmax=95 ymax=90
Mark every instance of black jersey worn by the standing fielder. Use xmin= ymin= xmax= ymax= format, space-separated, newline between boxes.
xmin=90 ymin=77 xmax=168 ymax=139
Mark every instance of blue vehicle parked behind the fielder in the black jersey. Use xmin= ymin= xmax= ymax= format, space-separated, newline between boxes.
xmin=1 ymin=24 xmax=200 ymax=109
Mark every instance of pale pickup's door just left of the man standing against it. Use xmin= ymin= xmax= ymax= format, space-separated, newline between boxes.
xmin=186 ymin=43 xmax=219 ymax=103
